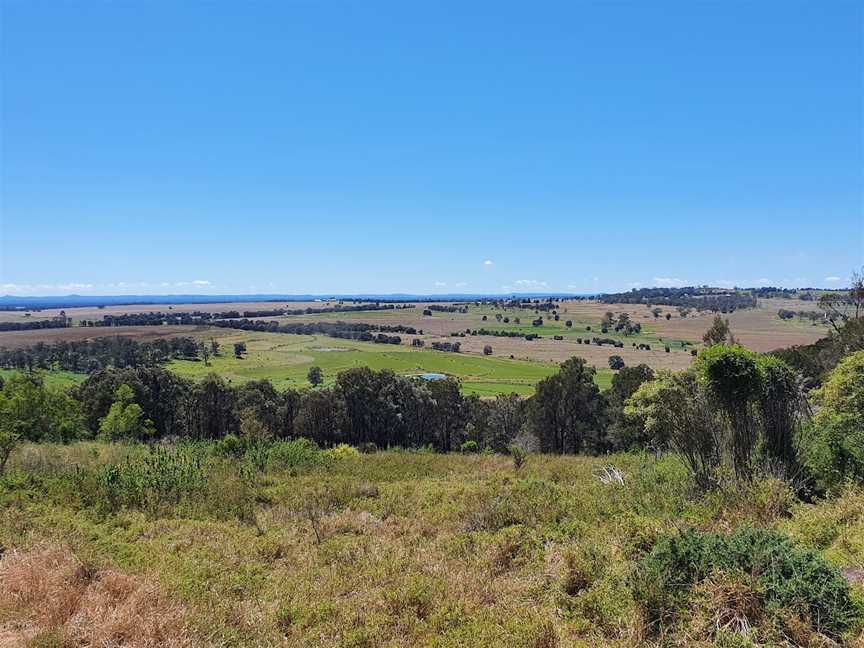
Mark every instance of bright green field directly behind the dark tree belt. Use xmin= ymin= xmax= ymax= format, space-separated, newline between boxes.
xmin=168 ymin=331 xmax=612 ymax=396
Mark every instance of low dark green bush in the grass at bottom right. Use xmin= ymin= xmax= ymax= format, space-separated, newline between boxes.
xmin=633 ymin=527 xmax=858 ymax=637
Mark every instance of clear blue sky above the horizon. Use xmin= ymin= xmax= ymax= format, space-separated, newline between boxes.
xmin=0 ymin=0 xmax=864 ymax=294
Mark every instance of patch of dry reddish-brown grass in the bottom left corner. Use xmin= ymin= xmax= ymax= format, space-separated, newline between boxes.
xmin=0 ymin=545 xmax=191 ymax=648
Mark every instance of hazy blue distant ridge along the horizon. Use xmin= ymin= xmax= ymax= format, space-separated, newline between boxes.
xmin=0 ymin=292 xmax=595 ymax=310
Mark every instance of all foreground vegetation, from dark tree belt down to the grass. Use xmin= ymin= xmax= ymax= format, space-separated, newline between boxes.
xmin=0 ymin=282 xmax=864 ymax=648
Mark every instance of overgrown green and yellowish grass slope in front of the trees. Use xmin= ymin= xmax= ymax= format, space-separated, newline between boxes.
xmin=0 ymin=443 xmax=864 ymax=648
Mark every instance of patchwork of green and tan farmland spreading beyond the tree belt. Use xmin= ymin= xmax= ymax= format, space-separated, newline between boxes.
xmin=0 ymin=299 xmax=827 ymax=396
